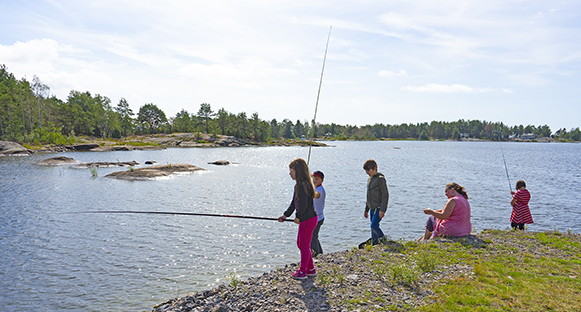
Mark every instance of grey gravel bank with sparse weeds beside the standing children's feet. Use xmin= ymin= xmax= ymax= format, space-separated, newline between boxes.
xmin=153 ymin=231 xmax=581 ymax=312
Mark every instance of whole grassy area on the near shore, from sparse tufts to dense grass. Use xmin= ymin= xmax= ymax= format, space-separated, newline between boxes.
xmin=326 ymin=230 xmax=581 ymax=311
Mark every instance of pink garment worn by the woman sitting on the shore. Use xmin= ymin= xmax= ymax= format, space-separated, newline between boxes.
xmin=434 ymin=195 xmax=472 ymax=237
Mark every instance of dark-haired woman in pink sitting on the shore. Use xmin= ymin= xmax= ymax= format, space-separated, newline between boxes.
xmin=424 ymin=183 xmax=472 ymax=240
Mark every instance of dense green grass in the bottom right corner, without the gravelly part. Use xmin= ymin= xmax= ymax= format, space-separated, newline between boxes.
xmin=418 ymin=231 xmax=581 ymax=311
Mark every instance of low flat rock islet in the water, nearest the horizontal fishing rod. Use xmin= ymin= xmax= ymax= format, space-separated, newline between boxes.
xmin=105 ymin=164 xmax=205 ymax=180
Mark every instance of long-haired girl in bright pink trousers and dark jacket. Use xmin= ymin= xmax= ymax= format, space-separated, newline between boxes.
xmin=278 ymin=158 xmax=318 ymax=280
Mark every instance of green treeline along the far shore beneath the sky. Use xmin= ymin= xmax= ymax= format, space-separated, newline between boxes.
xmin=0 ymin=65 xmax=581 ymax=145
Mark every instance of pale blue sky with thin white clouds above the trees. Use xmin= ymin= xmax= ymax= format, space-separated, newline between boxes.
xmin=0 ymin=0 xmax=581 ymax=131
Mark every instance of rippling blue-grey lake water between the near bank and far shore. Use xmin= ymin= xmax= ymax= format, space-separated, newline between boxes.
xmin=0 ymin=141 xmax=581 ymax=311
